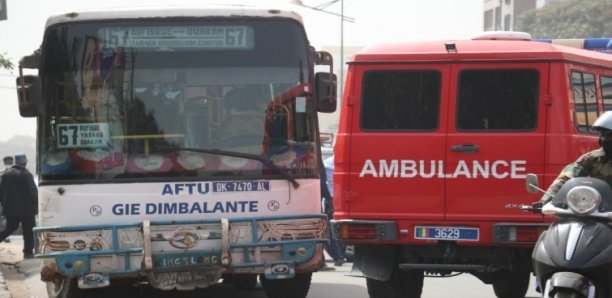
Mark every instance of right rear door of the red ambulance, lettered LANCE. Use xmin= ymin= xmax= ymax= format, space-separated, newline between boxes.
xmin=444 ymin=62 xmax=548 ymax=222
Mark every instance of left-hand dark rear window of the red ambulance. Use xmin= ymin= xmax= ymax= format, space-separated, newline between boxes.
xmin=361 ymin=70 xmax=441 ymax=131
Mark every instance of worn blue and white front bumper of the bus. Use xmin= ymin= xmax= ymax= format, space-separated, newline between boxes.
xmin=34 ymin=214 xmax=328 ymax=289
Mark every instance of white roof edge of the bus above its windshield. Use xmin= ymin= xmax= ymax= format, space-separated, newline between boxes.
xmin=46 ymin=5 xmax=303 ymax=27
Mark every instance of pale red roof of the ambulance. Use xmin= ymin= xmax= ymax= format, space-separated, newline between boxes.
xmin=349 ymin=40 xmax=612 ymax=68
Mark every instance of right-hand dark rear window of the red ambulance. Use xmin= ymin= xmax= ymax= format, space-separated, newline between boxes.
xmin=457 ymin=69 xmax=539 ymax=131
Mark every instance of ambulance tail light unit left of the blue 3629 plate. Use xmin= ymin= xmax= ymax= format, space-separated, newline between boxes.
xmin=332 ymin=220 xmax=397 ymax=241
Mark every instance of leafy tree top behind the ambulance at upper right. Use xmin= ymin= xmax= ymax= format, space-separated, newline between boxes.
xmin=514 ymin=0 xmax=612 ymax=38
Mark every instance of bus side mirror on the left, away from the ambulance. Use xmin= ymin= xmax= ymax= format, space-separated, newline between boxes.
xmin=17 ymin=75 xmax=42 ymax=117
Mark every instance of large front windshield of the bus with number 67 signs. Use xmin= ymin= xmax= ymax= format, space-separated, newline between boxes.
xmin=38 ymin=18 xmax=318 ymax=182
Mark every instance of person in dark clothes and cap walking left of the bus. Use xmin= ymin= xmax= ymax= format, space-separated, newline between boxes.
xmin=0 ymin=154 xmax=38 ymax=259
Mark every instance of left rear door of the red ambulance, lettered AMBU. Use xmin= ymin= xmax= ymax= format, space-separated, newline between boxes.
xmin=349 ymin=63 xmax=450 ymax=220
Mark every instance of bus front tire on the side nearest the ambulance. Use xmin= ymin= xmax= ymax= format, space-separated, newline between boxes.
xmin=259 ymin=273 xmax=312 ymax=298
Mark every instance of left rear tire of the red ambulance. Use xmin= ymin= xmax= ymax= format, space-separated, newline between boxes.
xmin=366 ymin=267 xmax=424 ymax=298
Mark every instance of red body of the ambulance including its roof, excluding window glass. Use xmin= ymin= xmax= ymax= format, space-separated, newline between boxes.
xmin=333 ymin=40 xmax=612 ymax=246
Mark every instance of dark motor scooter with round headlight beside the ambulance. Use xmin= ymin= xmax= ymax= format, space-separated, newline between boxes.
xmin=521 ymin=174 xmax=612 ymax=298
